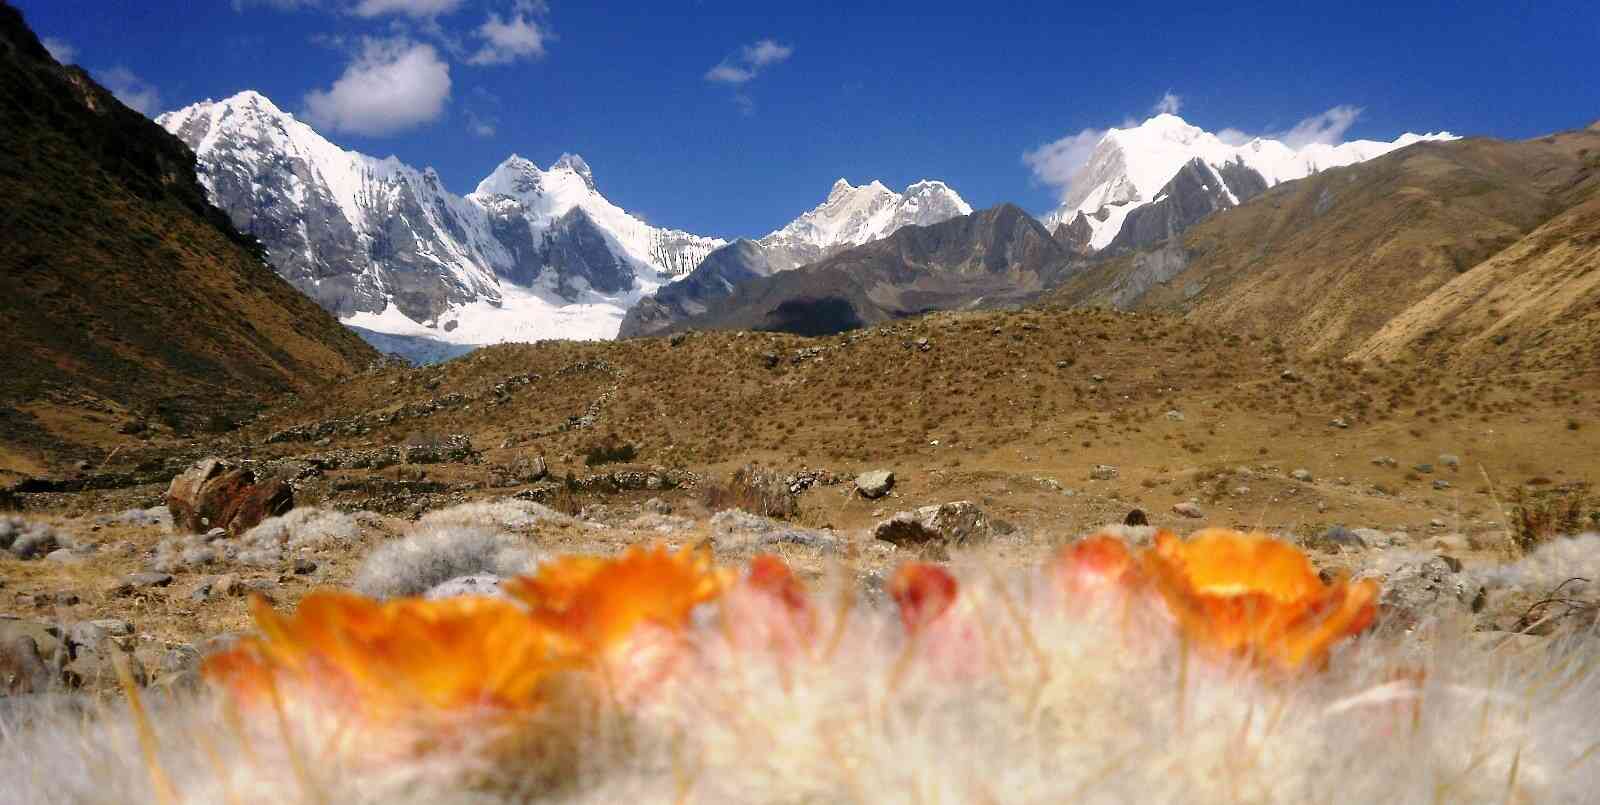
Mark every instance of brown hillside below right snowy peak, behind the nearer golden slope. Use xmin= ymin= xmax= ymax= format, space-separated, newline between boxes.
xmin=1056 ymin=131 xmax=1600 ymax=355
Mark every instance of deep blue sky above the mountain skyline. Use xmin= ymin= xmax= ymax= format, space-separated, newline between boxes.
xmin=13 ymin=0 xmax=1600 ymax=235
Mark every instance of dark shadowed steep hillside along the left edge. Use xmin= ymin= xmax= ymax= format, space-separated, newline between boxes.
xmin=0 ymin=3 xmax=376 ymax=474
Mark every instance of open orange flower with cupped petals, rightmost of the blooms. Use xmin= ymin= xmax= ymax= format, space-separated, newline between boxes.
xmin=1139 ymin=528 xmax=1378 ymax=671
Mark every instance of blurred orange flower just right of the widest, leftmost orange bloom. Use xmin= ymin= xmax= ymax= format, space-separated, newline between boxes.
xmin=506 ymin=546 xmax=728 ymax=653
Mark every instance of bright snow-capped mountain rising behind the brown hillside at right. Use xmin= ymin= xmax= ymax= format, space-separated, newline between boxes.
xmin=1043 ymin=114 xmax=1454 ymax=250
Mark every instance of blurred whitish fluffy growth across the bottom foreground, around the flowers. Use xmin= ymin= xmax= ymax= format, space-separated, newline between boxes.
xmin=0 ymin=556 xmax=1600 ymax=803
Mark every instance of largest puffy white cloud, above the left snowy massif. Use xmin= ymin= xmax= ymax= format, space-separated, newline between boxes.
xmin=306 ymin=38 xmax=450 ymax=136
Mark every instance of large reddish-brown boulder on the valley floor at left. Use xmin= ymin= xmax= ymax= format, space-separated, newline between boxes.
xmin=166 ymin=458 xmax=294 ymax=536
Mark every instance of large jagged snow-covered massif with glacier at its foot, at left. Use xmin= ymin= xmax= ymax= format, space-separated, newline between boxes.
xmin=157 ymin=91 xmax=726 ymax=347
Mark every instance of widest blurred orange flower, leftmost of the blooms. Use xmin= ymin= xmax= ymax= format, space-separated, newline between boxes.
xmin=205 ymin=592 xmax=571 ymax=719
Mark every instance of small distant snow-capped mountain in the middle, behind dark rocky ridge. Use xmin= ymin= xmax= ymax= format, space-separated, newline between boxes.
xmin=757 ymin=179 xmax=973 ymax=270
